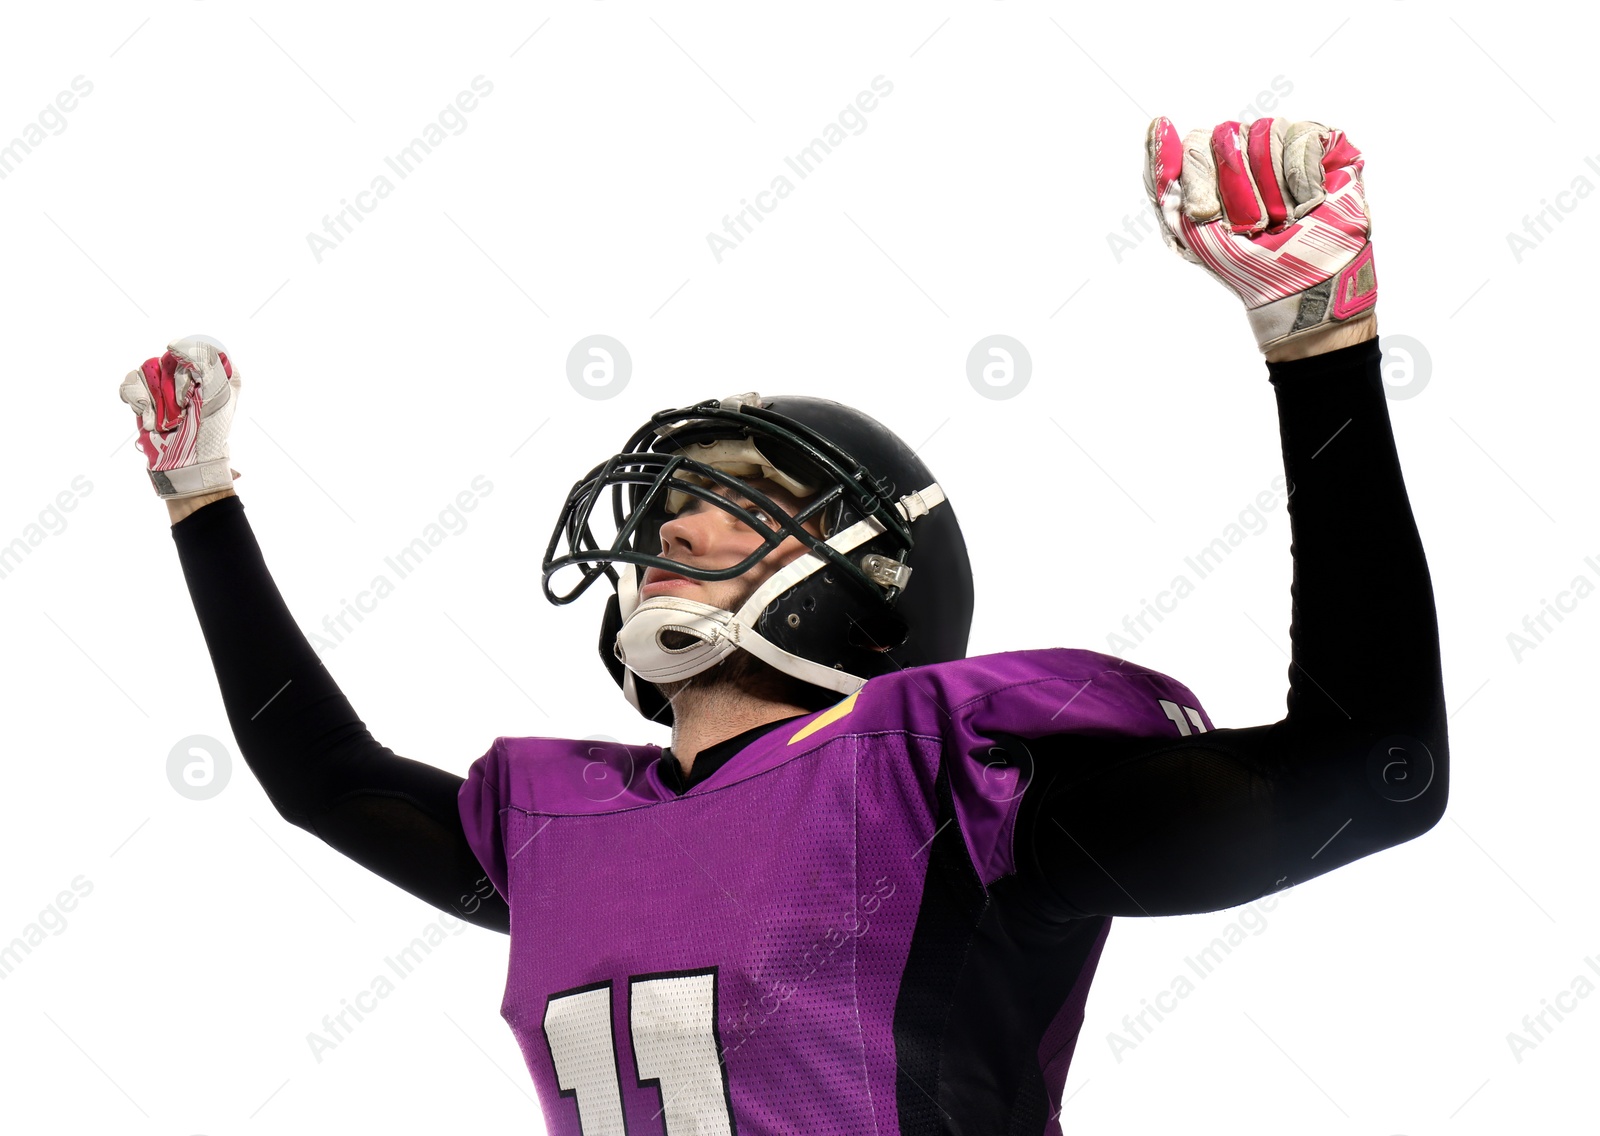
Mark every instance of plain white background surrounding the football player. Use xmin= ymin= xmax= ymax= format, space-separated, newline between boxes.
xmin=0 ymin=2 xmax=1600 ymax=1136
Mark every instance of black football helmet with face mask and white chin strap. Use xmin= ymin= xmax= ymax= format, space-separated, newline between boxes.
xmin=542 ymin=392 xmax=973 ymax=725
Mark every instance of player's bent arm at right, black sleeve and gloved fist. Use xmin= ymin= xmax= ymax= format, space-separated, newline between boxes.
xmin=1010 ymin=118 xmax=1448 ymax=915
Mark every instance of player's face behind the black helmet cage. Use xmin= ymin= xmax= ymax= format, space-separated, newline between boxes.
xmin=640 ymin=478 xmax=822 ymax=611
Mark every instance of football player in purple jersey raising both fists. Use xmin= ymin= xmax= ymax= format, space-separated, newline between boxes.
xmin=122 ymin=118 xmax=1448 ymax=1136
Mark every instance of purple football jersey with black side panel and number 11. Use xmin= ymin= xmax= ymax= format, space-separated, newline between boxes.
xmin=459 ymin=650 xmax=1211 ymax=1136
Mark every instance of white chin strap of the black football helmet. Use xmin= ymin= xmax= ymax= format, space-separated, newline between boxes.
xmin=614 ymin=482 xmax=944 ymax=709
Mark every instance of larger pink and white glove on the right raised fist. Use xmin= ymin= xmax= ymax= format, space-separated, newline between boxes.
xmin=1144 ymin=118 xmax=1378 ymax=352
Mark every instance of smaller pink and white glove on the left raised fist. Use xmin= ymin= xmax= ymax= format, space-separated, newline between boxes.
xmin=118 ymin=336 xmax=240 ymax=501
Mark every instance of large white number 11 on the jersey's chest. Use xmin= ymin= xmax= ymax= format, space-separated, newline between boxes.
xmin=544 ymin=970 xmax=734 ymax=1136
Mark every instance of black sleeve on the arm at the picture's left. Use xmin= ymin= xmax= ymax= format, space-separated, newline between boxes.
xmin=171 ymin=496 xmax=510 ymax=931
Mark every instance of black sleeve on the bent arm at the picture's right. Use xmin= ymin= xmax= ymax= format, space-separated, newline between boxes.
xmin=1008 ymin=338 xmax=1448 ymax=915
